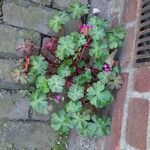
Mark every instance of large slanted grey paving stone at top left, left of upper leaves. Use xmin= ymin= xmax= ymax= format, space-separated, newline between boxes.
xmin=3 ymin=0 xmax=57 ymax=35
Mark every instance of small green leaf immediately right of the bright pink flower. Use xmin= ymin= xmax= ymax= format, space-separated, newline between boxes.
xmin=89 ymin=27 xmax=106 ymax=40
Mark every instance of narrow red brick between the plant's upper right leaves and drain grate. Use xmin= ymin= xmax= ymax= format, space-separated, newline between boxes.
xmin=119 ymin=27 xmax=135 ymax=68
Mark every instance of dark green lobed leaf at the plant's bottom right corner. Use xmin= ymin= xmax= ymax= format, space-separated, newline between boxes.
xmin=88 ymin=115 xmax=110 ymax=137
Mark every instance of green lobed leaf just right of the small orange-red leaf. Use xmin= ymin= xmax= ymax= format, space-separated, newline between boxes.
xmin=28 ymin=55 xmax=48 ymax=83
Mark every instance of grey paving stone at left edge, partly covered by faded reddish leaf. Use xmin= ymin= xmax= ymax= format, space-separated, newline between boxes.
xmin=0 ymin=24 xmax=41 ymax=54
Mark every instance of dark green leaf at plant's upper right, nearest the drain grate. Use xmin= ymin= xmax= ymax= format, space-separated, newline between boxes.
xmin=108 ymin=26 xmax=125 ymax=49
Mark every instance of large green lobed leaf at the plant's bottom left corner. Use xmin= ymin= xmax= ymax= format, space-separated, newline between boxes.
xmin=51 ymin=110 xmax=72 ymax=133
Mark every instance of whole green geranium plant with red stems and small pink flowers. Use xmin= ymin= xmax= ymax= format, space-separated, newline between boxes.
xmin=14 ymin=3 xmax=125 ymax=137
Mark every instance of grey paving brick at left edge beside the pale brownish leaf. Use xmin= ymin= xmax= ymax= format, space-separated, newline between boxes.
xmin=0 ymin=59 xmax=18 ymax=82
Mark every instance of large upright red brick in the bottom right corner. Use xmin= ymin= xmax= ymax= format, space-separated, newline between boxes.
xmin=126 ymin=99 xmax=149 ymax=150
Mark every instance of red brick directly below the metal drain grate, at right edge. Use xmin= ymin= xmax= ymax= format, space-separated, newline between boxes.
xmin=134 ymin=67 xmax=150 ymax=92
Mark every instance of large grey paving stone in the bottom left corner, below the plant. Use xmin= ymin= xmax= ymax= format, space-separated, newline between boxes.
xmin=0 ymin=119 xmax=56 ymax=150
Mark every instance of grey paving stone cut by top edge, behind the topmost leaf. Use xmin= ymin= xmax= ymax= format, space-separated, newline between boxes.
xmin=53 ymin=0 xmax=88 ymax=10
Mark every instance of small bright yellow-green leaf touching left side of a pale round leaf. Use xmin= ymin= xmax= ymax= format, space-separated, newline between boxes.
xmin=36 ymin=76 xmax=49 ymax=93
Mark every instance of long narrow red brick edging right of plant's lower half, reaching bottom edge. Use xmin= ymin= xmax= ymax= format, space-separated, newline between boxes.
xmin=98 ymin=73 xmax=128 ymax=150
